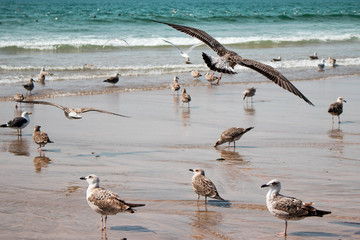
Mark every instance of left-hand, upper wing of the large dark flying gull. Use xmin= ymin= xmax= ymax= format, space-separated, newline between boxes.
xmin=152 ymin=20 xmax=226 ymax=57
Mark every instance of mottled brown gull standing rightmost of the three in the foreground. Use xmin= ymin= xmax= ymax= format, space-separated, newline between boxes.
xmin=261 ymin=179 xmax=331 ymax=236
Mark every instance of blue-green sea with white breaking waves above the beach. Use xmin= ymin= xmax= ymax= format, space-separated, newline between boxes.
xmin=0 ymin=0 xmax=360 ymax=99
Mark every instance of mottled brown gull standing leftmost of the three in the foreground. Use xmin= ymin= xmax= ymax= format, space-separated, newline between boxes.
xmin=80 ymin=174 xmax=145 ymax=230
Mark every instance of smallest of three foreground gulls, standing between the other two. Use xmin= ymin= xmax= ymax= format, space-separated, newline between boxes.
xmin=189 ymin=168 xmax=225 ymax=204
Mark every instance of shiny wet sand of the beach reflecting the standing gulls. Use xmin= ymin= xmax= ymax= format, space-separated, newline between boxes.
xmin=0 ymin=76 xmax=360 ymax=239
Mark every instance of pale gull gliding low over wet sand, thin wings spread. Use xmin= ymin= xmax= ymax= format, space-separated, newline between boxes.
xmin=23 ymin=101 xmax=128 ymax=119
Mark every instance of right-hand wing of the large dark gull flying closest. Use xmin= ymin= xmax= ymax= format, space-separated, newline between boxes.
xmin=237 ymin=58 xmax=314 ymax=106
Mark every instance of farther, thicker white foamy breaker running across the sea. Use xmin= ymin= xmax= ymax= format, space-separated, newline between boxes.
xmin=0 ymin=32 xmax=360 ymax=51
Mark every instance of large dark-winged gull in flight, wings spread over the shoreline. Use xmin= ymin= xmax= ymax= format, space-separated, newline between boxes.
xmin=153 ymin=20 xmax=314 ymax=105
